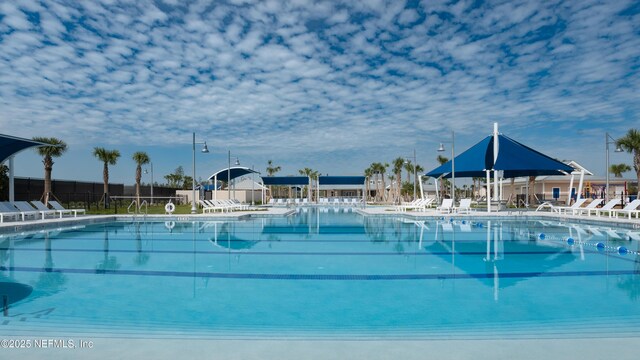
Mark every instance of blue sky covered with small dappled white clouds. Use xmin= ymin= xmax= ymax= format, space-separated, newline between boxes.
xmin=0 ymin=0 xmax=640 ymax=184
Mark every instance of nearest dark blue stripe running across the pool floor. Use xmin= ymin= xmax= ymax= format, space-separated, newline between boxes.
xmin=8 ymin=266 xmax=640 ymax=281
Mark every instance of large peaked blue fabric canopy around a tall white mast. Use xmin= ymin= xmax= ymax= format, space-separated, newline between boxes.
xmin=425 ymin=135 xmax=574 ymax=179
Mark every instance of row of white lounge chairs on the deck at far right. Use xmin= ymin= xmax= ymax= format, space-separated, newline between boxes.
xmin=536 ymin=199 xmax=640 ymax=219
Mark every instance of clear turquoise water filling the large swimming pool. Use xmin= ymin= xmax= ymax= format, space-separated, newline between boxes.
xmin=0 ymin=209 xmax=640 ymax=338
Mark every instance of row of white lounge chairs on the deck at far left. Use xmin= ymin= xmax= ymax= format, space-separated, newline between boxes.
xmin=0 ymin=201 xmax=85 ymax=222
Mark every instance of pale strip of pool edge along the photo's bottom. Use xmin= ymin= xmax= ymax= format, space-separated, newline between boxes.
xmin=8 ymin=338 xmax=640 ymax=360
